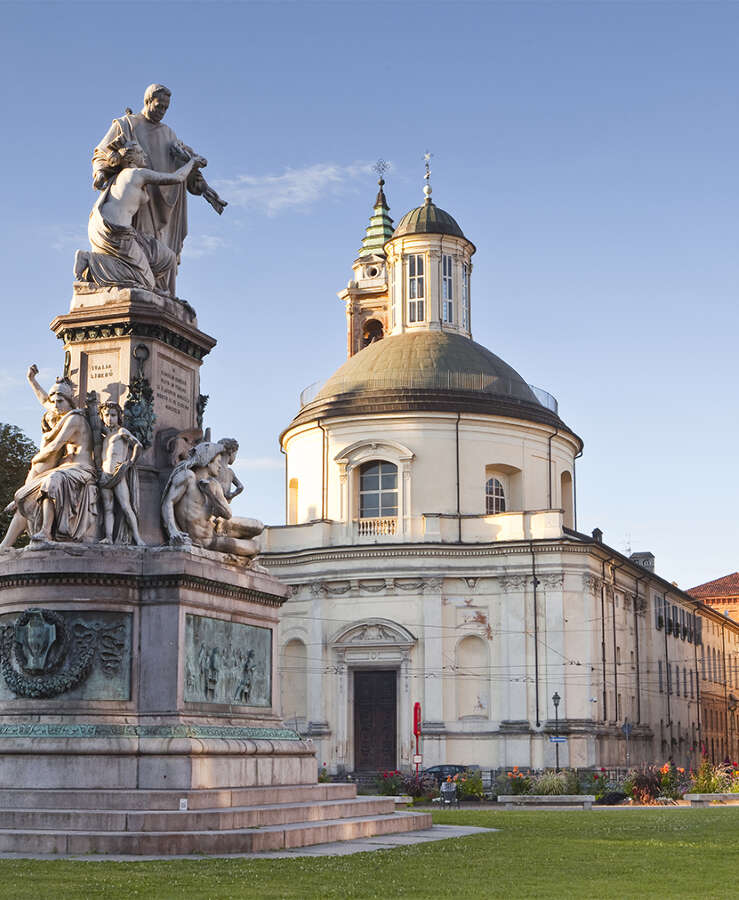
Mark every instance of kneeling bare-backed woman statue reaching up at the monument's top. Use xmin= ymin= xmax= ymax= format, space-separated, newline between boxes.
xmin=74 ymin=141 xmax=204 ymax=291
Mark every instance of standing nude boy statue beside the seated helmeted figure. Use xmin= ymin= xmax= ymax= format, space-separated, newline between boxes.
xmin=98 ymin=400 xmax=144 ymax=547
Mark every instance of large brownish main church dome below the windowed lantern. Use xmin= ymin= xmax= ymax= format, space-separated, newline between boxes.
xmin=290 ymin=330 xmax=580 ymax=442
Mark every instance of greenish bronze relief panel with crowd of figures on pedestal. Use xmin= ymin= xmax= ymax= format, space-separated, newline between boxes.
xmin=185 ymin=615 xmax=272 ymax=706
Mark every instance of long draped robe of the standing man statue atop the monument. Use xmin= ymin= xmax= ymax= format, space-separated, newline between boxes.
xmin=92 ymin=113 xmax=189 ymax=297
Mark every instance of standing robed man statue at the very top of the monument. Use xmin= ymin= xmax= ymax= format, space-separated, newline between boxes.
xmin=92 ymin=84 xmax=226 ymax=297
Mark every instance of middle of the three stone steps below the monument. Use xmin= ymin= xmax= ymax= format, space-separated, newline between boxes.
xmin=0 ymin=797 xmax=395 ymax=832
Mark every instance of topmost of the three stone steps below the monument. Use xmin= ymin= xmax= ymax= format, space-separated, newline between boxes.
xmin=0 ymin=782 xmax=357 ymax=811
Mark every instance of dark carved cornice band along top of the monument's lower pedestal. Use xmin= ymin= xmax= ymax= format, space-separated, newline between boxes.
xmin=0 ymin=572 xmax=285 ymax=608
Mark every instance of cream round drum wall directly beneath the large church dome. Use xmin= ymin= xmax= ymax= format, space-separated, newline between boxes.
xmin=283 ymin=413 xmax=578 ymax=539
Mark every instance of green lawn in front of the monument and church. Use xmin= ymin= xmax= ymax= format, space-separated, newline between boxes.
xmin=0 ymin=808 xmax=739 ymax=900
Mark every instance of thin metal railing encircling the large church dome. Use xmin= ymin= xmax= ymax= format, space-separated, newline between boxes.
xmin=300 ymin=371 xmax=559 ymax=415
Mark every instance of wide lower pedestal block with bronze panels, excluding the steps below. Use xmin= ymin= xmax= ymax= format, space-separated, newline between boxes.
xmin=0 ymin=544 xmax=316 ymax=790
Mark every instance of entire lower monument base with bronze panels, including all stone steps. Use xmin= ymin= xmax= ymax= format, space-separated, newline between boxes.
xmin=0 ymin=544 xmax=431 ymax=855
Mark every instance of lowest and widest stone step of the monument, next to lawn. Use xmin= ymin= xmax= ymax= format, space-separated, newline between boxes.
xmin=0 ymin=812 xmax=431 ymax=856
